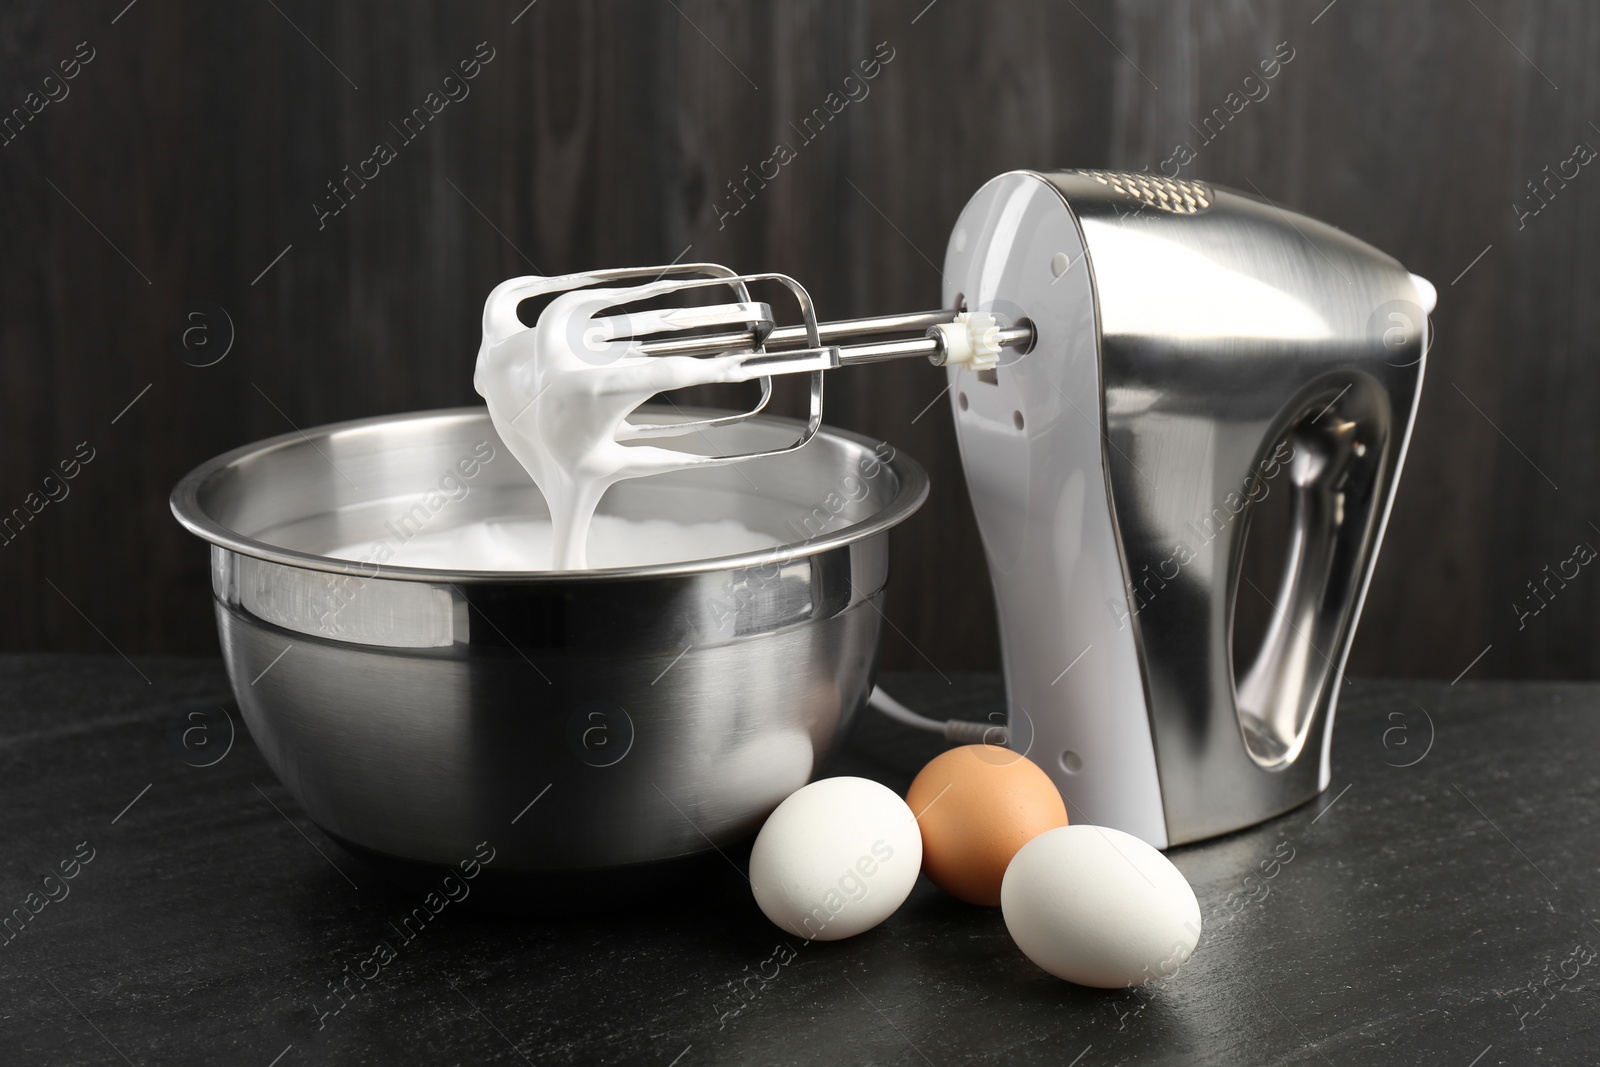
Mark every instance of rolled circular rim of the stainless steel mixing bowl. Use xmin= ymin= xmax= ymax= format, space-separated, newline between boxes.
xmin=170 ymin=405 xmax=928 ymax=585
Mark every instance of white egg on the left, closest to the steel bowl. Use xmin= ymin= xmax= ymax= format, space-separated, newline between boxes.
xmin=750 ymin=777 xmax=922 ymax=941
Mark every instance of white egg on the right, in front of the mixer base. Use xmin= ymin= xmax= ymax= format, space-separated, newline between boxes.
xmin=1000 ymin=825 xmax=1200 ymax=989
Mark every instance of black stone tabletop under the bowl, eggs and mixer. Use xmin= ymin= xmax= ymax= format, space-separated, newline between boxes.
xmin=0 ymin=656 xmax=1600 ymax=1067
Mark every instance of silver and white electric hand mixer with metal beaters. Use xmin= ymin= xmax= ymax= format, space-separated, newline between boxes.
xmin=505 ymin=171 xmax=1434 ymax=848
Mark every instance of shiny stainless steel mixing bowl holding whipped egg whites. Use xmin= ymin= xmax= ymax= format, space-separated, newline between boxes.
xmin=171 ymin=408 xmax=928 ymax=872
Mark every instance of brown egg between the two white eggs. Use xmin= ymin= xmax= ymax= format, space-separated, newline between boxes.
xmin=906 ymin=745 xmax=1067 ymax=907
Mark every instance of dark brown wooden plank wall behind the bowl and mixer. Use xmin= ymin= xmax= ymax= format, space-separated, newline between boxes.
xmin=0 ymin=0 xmax=1600 ymax=678
